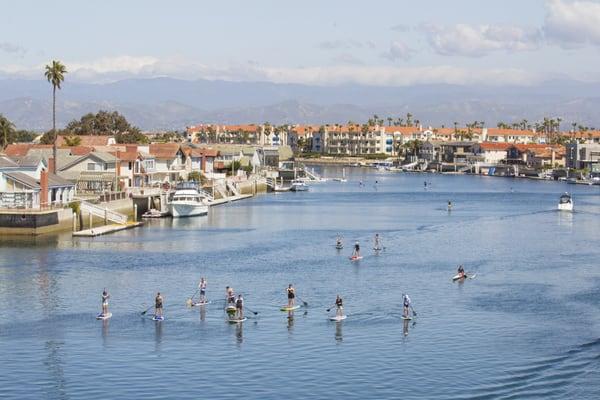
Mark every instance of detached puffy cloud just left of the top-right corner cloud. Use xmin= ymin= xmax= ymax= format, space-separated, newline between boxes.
xmin=420 ymin=24 xmax=543 ymax=57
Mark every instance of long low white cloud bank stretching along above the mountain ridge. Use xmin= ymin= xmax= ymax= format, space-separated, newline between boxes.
xmin=0 ymin=55 xmax=542 ymax=86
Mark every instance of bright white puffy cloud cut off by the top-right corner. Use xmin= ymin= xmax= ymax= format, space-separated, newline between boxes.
xmin=544 ymin=0 xmax=600 ymax=47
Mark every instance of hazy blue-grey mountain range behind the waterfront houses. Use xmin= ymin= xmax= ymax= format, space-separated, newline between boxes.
xmin=0 ymin=78 xmax=600 ymax=130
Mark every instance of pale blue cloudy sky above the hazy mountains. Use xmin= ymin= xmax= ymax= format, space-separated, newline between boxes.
xmin=0 ymin=0 xmax=600 ymax=86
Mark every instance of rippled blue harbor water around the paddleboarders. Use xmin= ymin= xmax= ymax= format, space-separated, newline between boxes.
xmin=0 ymin=168 xmax=600 ymax=399
